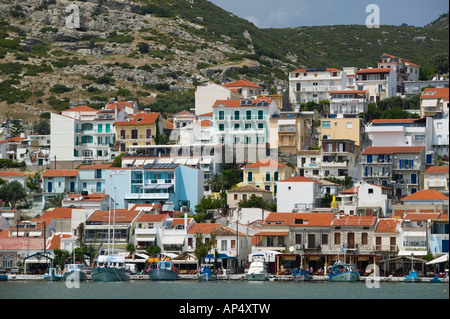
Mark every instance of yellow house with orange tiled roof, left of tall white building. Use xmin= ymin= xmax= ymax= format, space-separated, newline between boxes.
xmin=114 ymin=113 xmax=167 ymax=152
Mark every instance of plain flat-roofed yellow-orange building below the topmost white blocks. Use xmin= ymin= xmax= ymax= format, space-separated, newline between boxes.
xmin=319 ymin=118 xmax=363 ymax=146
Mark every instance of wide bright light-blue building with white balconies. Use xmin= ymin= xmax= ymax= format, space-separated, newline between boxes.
xmin=105 ymin=163 xmax=204 ymax=211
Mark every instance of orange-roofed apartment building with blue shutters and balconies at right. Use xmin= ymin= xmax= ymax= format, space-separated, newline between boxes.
xmin=360 ymin=146 xmax=425 ymax=197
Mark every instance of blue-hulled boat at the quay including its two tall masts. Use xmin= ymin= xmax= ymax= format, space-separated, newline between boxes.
xmin=91 ymin=190 xmax=130 ymax=282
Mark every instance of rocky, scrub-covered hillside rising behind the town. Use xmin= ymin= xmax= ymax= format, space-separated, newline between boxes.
xmin=0 ymin=0 xmax=448 ymax=122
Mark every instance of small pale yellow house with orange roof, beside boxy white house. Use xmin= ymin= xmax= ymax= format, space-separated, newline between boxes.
xmin=242 ymin=159 xmax=292 ymax=196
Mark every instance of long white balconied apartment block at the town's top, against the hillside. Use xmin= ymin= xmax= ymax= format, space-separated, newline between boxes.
xmin=289 ymin=68 xmax=347 ymax=105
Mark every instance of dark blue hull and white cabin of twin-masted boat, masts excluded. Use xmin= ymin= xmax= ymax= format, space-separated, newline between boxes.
xmin=91 ymin=255 xmax=130 ymax=282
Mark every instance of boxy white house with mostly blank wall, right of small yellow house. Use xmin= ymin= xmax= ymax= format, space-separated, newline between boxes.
xmin=277 ymin=176 xmax=321 ymax=213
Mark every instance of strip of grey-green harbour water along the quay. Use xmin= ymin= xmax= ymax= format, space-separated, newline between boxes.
xmin=0 ymin=275 xmax=449 ymax=301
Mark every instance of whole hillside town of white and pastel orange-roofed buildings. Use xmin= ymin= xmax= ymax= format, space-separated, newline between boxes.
xmin=0 ymin=53 xmax=449 ymax=276
